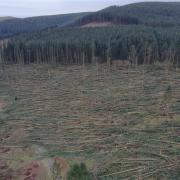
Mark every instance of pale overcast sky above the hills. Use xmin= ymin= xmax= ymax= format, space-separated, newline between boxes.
xmin=0 ymin=0 xmax=180 ymax=17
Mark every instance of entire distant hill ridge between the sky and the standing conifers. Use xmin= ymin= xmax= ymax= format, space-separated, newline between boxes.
xmin=0 ymin=2 xmax=180 ymax=38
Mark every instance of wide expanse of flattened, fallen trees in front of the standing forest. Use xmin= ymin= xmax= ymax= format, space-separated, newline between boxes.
xmin=0 ymin=64 xmax=180 ymax=180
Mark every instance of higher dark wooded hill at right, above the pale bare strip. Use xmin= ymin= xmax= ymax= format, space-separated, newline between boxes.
xmin=74 ymin=2 xmax=180 ymax=26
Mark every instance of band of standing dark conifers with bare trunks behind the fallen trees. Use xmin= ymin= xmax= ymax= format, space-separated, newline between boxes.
xmin=0 ymin=26 xmax=180 ymax=64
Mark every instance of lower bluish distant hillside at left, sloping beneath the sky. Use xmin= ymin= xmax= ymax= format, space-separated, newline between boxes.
xmin=0 ymin=13 xmax=88 ymax=38
